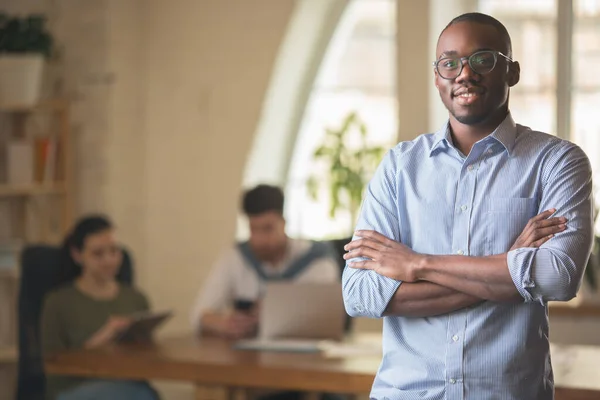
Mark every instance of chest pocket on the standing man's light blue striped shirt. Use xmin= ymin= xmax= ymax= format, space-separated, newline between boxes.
xmin=483 ymin=197 xmax=537 ymax=255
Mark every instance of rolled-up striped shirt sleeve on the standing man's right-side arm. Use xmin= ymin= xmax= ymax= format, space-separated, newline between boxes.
xmin=507 ymin=142 xmax=594 ymax=304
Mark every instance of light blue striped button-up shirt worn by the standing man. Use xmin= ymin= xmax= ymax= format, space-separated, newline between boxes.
xmin=343 ymin=114 xmax=593 ymax=400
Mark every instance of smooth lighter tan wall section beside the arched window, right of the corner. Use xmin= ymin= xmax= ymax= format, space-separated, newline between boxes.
xmin=141 ymin=0 xmax=294 ymax=332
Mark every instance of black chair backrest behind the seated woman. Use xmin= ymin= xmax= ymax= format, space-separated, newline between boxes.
xmin=16 ymin=245 xmax=133 ymax=400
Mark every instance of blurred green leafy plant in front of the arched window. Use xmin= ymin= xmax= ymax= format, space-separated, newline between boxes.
xmin=307 ymin=112 xmax=386 ymax=237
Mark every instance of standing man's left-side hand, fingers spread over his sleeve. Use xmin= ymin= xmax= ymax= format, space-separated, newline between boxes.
xmin=344 ymin=231 xmax=424 ymax=282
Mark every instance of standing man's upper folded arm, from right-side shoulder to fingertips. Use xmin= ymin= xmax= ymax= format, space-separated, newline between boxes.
xmin=350 ymin=145 xmax=593 ymax=303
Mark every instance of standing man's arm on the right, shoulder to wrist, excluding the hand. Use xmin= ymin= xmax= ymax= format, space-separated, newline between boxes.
xmin=416 ymin=145 xmax=593 ymax=304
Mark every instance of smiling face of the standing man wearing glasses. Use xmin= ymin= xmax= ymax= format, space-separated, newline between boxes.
xmin=435 ymin=22 xmax=519 ymax=125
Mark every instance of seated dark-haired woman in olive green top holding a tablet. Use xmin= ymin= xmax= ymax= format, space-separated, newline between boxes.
xmin=41 ymin=216 xmax=158 ymax=400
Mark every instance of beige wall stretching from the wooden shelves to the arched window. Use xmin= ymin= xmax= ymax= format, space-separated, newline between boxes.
xmin=0 ymin=0 xmax=294 ymax=333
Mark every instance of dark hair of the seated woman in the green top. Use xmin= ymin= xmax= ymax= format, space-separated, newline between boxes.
xmin=61 ymin=215 xmax=113 ymax=276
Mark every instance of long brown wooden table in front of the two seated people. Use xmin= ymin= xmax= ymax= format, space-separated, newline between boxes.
xmin=46 ymin=337 xmax=600 ymax=400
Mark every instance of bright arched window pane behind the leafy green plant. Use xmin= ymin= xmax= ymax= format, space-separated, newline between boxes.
xmin=286 ymin=0 xmax=398 ymax=239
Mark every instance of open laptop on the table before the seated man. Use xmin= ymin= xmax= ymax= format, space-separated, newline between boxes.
xmin=235 ymin=282 xmax=346 ymax=351
